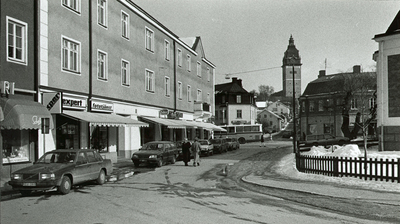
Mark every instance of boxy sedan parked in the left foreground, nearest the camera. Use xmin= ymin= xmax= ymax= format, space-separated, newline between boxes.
xmin=9 ymin=149 xmax=113 ymax=196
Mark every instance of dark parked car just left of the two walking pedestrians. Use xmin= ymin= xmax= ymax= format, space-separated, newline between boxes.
xmin=131 ymin=141 xmax=179 ymax=167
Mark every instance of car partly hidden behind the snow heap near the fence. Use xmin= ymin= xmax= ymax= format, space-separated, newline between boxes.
xmin=298 ymin=134 xmax=350 ymax=147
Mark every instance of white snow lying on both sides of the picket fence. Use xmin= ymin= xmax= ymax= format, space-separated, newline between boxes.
xmin=276 ymin=144 xmax=400 ymax=193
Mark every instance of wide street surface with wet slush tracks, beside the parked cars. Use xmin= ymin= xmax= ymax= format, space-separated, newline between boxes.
xmin=1 ymin=141 xmax=396 ymax=224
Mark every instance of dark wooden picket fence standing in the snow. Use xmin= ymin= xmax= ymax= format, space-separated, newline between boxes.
xmin=296 ymin=155 xmax=400 ymax=183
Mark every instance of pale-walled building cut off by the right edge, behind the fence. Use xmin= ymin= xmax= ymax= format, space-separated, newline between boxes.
xmin=374 ymin=11 xmax=400 ymax=151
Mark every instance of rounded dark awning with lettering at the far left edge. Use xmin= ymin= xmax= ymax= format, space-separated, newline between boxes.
xmin=0 ymin=98 xmax=53 ymax=129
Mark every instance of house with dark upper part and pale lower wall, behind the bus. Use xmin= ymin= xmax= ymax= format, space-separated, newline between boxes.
xmin=215 ymin=78 xmax=257 ymax=125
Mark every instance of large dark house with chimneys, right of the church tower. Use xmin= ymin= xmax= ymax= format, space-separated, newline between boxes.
xmin=299 ymin=65 xmax=376 ymax=141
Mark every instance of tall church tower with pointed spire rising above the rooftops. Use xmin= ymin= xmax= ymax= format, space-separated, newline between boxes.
xmin=282 ymin=35 xmax=301 ymax=98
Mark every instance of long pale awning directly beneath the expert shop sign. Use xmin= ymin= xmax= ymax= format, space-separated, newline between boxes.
xmin=63 ymin=110 xmax=149 ymax=127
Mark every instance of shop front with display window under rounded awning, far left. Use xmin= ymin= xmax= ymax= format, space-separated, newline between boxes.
xmin=0 ymin=96 xmax=53 ymax=187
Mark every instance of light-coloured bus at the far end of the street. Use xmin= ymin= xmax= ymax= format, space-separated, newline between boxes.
xmin=214 ymin=124 xmax=263 ymax=144
